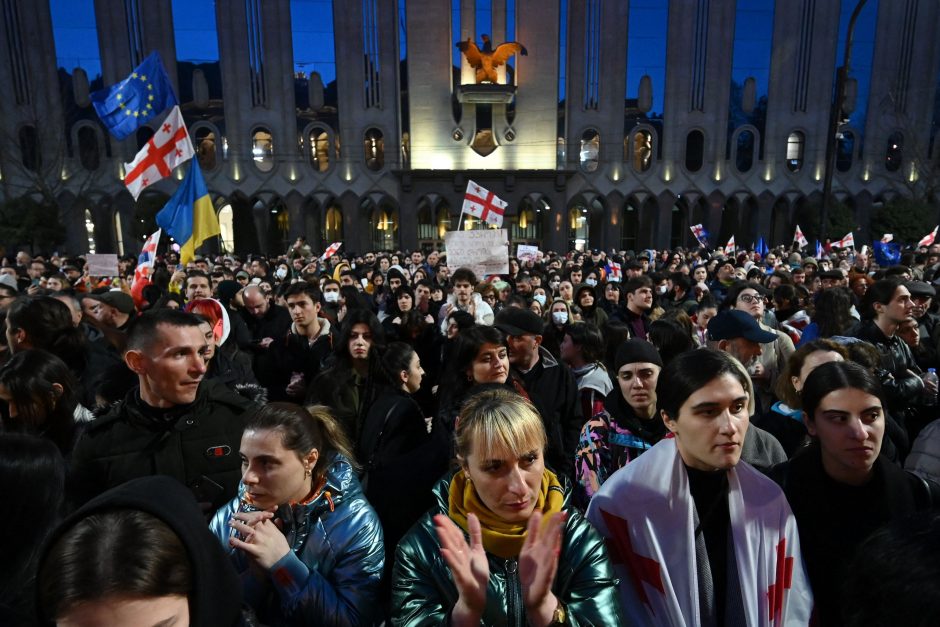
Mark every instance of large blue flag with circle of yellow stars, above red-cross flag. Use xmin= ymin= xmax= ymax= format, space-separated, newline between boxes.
xmin=91 ymin=52 xmax=178 ymax=139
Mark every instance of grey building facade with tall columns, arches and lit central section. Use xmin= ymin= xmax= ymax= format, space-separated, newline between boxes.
xmin=0 ymin=0 xmax=940 ymax=253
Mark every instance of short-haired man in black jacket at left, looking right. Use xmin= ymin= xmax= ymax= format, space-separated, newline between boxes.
xmin=70 ymin=309 xmax=254 ymax=511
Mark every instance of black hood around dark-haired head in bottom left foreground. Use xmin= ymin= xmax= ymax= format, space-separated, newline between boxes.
xmin=39 ymin=476 xmax=243 ymax=627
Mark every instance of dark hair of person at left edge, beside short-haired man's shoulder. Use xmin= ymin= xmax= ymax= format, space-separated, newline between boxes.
xmin=0 ymin=349 xmax=78 ymax=455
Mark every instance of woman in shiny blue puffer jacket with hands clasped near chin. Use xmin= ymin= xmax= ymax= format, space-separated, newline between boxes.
xmin=210 ymin=403 xmax=384 ymax=626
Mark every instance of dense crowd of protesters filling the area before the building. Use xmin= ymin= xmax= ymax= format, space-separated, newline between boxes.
xmin=0 ymin=238 xmax=940 ymax=626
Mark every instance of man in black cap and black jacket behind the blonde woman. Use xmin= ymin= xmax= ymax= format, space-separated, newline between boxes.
xmin=493 ymin=307 xmax=584 ymax=480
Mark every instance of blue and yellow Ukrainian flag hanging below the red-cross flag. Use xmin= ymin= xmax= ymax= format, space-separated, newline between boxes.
xmin=157 ymin=159 xmax=222 ymax=266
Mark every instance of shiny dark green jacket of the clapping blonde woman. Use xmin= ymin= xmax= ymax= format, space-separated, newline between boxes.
xmin=392 ymin=476 xmax=624 ymax=627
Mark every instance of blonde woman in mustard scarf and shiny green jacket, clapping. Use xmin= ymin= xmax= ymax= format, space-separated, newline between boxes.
xmin=391 ymin=386 xmax=623 ymax=627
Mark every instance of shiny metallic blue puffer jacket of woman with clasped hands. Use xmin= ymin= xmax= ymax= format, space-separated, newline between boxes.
xmin=209 ymin=455 xmax=385 ymax=627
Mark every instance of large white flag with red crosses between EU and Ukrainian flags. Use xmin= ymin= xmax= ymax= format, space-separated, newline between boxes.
xmin=124 ymin=106 xmax=194 ymax=200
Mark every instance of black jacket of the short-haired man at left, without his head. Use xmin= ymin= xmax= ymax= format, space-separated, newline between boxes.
xmin=69 ymin=380 xmax=256 ymax=507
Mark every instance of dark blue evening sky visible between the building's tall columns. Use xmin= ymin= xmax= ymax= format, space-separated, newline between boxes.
xmin=50 ymin=0 xmax=878 ymax=126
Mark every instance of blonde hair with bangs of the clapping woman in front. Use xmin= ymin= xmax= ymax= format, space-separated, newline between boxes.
xmin=454 ymin=387 xmax=548 ymax=462
